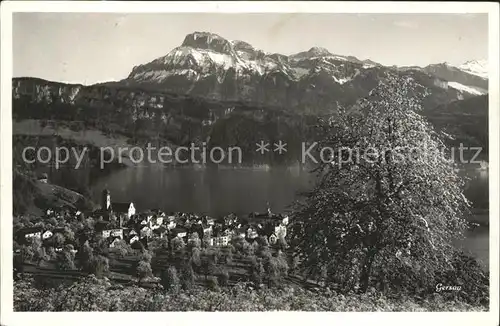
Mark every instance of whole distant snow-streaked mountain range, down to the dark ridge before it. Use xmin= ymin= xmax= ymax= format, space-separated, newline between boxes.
xmin=119 ymin=32 xmax=487 ymax=113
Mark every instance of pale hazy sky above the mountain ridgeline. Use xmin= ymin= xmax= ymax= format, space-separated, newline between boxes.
xmin=13 ymin=13 xmax=488 ymax=84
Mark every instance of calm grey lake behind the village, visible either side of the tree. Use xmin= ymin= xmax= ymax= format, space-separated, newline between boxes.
xmin=85 ymin=166 xmax=489 ymax=266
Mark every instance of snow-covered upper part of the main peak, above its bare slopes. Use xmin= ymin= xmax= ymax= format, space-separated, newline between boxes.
xmin=128 ymin=32 xmax=363 ymax=84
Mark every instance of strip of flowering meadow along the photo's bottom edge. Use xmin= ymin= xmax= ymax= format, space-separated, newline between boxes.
xmin=14 ymin=276 xmax=487 ymax=311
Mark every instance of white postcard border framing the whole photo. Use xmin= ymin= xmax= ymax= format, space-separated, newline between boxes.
xmin=0 ymin=1 xmax=500 ymax=326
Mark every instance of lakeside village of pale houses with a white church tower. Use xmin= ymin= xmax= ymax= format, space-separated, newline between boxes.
xmin=14 ymin=189 xmax=289 ymax=260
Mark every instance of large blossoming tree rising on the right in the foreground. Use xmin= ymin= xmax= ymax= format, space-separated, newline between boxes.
xmin=292 ymin=74 xmax=468 ymax=291
